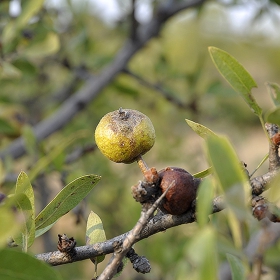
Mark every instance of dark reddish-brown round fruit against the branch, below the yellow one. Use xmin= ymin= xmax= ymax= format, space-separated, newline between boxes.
xmin=159 ymin=167 xmax=200 ymax=215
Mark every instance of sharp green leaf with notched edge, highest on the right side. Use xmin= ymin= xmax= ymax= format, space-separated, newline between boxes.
xmin=208 ymin=47 xmax=262 ymax=116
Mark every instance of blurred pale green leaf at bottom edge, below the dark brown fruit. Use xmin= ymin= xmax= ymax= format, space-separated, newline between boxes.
xmin=188 ymin=227 xmax=218 ymax=280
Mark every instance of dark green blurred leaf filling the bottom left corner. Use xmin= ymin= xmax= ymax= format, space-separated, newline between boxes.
xmin=0 ymin=249 xmax=62 ymax=280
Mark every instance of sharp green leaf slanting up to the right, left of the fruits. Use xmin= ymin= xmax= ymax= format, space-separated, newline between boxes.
xmin=35 ymin=175 xmax=101 ymax=235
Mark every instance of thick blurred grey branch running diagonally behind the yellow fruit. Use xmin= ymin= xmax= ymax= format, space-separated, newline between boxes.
xmin=0 ymin=0 xmax=206 ymax=159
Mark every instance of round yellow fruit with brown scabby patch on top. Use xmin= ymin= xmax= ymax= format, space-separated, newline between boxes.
xmin=95 ymin=109 xmax=156 ymax=163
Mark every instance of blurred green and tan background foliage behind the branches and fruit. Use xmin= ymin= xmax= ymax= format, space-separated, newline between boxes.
xmin=0 ymin=0 xmax=280 ymax=280
